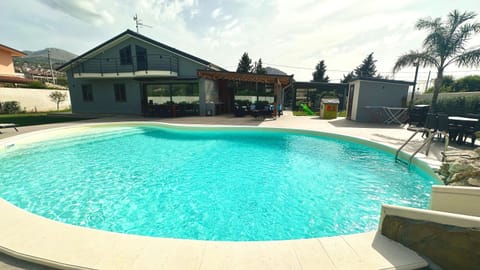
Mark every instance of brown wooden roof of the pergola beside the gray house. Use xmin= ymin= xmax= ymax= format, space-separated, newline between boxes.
xmin=197 ymin=70 xmax=293 ymax=85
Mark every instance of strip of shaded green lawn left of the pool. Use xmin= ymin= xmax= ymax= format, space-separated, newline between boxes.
xmin=0 ymin=113 xmax=92 ymax=126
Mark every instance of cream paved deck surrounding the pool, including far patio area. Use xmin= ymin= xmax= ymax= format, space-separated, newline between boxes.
xmin=0 ymin=112 xmax=468 ymax=269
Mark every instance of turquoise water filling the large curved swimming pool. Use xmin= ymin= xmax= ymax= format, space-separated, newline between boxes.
xmin=0 ymin=126 xmax=436 ymax=241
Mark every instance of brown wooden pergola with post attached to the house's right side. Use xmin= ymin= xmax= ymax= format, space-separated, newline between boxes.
xmin=197 ymin=70 xmax=293 ymax=115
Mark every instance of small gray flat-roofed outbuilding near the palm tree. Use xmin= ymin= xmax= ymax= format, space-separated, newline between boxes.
xmin=347 ymin=78 xmax=413 ymax=122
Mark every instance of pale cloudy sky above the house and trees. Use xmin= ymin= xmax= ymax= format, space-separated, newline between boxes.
xmin=0 ymin=0 xmax=480 ymax=87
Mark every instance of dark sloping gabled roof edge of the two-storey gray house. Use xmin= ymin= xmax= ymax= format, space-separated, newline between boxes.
xmin=57 ymin=29 xmax=224 ymax=71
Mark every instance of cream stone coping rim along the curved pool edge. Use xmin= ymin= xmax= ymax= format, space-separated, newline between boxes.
xmin=0 ymin=121 xmax=428 ymax=269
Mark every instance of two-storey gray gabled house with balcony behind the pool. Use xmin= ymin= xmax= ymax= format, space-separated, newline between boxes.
xmin=58 ymin=30 xmax=224 ymax=117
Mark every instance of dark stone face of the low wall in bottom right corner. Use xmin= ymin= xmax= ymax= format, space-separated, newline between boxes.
xmin=382 ymin=216 xmax=480 ymax=269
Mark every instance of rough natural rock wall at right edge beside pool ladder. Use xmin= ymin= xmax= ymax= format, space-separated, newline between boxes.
xmin=439 ymin=148 xmax=480 ymax=187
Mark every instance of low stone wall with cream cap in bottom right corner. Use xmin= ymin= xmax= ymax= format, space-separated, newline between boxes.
xmin=379 ymin=205 xmax=480 ymax=269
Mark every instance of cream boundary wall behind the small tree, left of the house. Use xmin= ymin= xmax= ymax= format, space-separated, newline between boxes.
xmin=0 ymin=87 xmax=71 ymax=112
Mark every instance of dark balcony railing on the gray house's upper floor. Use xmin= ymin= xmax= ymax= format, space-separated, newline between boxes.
xmin=72 ymin=54 xmax=178 ymax=78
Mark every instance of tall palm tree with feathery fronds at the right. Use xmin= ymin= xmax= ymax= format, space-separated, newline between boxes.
xmin=393 ymin=10 xmax=480 ymax=112
